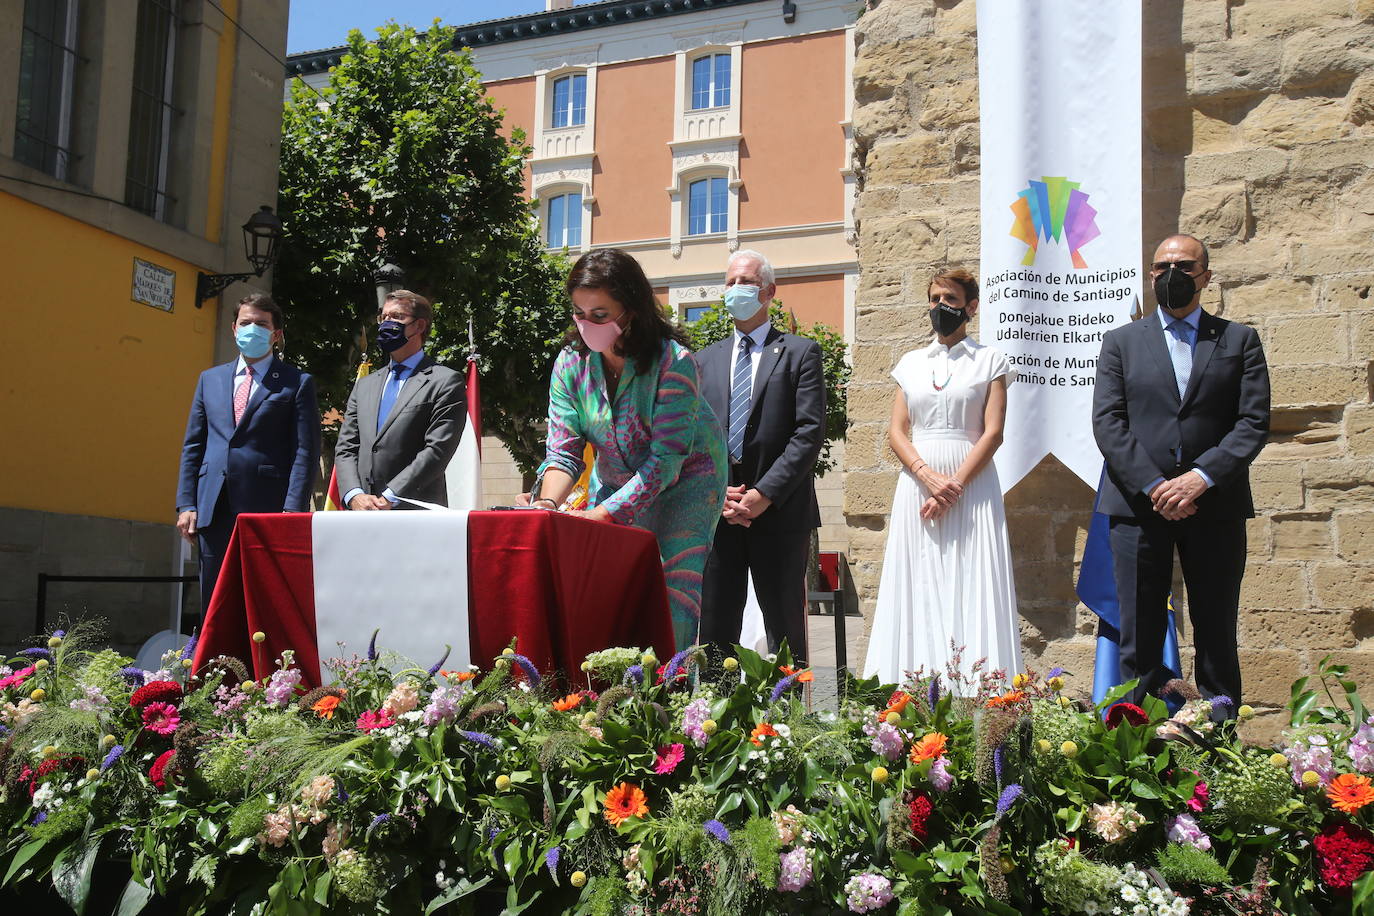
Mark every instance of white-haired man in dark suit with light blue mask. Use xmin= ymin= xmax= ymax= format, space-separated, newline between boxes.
xmin=697 ymin=250 xmax=826 ymax=663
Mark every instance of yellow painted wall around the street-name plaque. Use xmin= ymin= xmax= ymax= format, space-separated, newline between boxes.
xmin=0 ymin=191 xmax=216 ymax=523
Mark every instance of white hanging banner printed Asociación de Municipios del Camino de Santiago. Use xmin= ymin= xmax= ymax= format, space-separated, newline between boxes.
xmin=978 ymin=0 xmax=1142 ymax=490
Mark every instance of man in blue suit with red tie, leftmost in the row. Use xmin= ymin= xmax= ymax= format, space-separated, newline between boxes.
xmin=176 ymin=293 xmax=320 ymax=612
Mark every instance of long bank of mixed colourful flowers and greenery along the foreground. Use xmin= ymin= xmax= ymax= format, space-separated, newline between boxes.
xmin=0 ymin=630 xmax=1374 ymax=916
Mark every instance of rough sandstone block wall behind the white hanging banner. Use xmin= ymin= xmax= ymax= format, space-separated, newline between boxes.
xmin=845 ymin=0 xmax=1374 ymax=736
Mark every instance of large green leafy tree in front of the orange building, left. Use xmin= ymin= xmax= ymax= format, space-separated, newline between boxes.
xmin=275 ymin=22 xmax=567 ymax=468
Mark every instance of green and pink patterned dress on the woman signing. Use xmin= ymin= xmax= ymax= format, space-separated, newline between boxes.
xmin=539 ymin=341 xmax=728 ymax=650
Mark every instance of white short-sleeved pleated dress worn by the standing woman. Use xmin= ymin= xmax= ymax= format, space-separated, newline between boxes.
xmin=864 ymin=338 xmax=1021 ymax=683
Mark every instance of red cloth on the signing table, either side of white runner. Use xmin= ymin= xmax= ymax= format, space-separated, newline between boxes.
xmin=194 ymin=509 xmax=673 ymax=687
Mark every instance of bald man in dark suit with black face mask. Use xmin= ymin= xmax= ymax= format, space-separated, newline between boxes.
xmin=1092 ymin=235 xmax=1270 ymax=718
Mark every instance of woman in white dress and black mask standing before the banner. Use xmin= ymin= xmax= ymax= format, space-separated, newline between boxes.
xmin=864 ymin=271 xmax=1021 ymax=694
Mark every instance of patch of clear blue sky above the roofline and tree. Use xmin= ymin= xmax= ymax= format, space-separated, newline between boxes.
xmin=286 ymin=0 xmax=544 ymax=54
